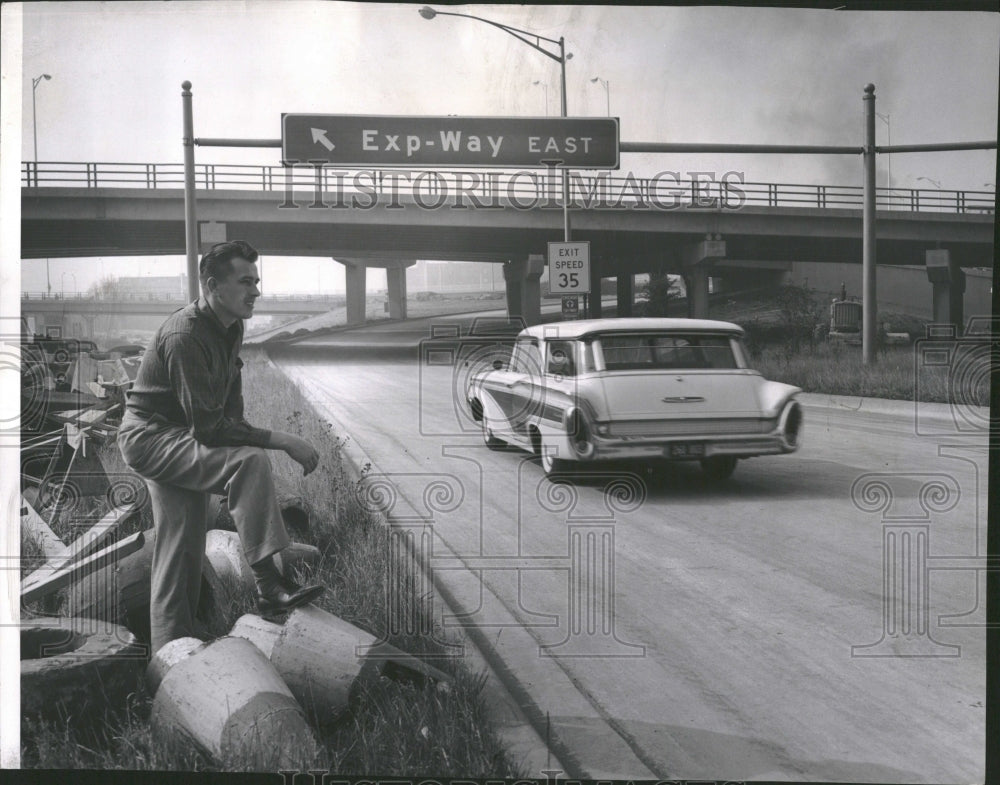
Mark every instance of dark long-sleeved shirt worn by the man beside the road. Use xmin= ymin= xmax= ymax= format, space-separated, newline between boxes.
xmin=126 ymin=298 xmax=271 ymax=447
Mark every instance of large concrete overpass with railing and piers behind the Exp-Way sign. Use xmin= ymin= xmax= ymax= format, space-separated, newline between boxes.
xmin=22 ymin=163 xmax=994 ymax=322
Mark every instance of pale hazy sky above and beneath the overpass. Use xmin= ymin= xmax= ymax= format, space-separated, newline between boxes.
xmin=5 ymin=0 xmax=1000 ymax=293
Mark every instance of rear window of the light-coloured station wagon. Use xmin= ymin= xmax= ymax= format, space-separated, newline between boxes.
xmin=597 ymin=332 xmax=738 ymax=371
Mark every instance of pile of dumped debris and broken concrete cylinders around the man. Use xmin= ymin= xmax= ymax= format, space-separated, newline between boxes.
xmin=20 ymin=336 xmax=450 ymax=771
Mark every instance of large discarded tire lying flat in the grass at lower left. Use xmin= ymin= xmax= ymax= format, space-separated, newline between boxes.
xmin=20 ymin=617 xmax=149 ymax=723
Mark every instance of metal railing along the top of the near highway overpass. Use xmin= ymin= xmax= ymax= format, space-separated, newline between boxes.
xmin=21 ymin=161 xmax=995 ymax=214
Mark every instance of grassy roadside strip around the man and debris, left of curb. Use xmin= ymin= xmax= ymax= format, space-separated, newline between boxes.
xmin=22 ymin=351 xmax=523 ymax=778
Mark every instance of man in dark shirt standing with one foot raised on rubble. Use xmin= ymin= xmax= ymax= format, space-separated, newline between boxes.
xmin=118 ymin=241 xmax=323 ymax=653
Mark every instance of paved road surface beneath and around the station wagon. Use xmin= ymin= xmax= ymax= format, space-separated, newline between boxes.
xmin=276 ymin=318 xmax=986 ymax=782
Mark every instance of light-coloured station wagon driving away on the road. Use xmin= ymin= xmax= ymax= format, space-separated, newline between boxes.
xmin=466 ymin=318 xmax=802 ymax=479
